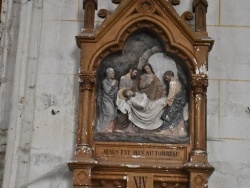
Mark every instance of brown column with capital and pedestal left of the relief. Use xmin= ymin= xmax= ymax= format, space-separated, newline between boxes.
xmin=68 ymin=72 xmax=97 ymax=188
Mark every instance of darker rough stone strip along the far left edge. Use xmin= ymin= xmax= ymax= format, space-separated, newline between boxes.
xmin=0 ymin=0 xmax=20 ymax=186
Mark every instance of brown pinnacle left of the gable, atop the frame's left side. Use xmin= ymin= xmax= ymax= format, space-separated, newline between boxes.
xmin=83 ymin=0 xmax=97 ymax=30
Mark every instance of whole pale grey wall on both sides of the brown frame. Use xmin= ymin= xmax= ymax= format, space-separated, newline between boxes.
xmin=0 ymin=0 xmax=250 ymax=188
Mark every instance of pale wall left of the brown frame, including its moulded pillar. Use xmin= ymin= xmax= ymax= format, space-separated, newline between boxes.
xmin=1 ymin=0 xmax=82 ymax=188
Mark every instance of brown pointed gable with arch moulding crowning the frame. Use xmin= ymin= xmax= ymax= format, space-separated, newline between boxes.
xmin=76 ymin=0 xmax=213 ymax=71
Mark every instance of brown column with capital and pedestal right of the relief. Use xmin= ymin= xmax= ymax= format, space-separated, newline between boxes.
xmin=184 ymin=74 xmax=214 ymax=188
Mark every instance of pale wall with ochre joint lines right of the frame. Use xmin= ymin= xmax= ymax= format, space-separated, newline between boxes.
xmin=208 ymin=0 xmax=250 ymax=188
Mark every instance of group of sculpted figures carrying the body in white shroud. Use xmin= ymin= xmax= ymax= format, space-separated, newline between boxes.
xmin=97 ymin=63 xmax=187 ymax=136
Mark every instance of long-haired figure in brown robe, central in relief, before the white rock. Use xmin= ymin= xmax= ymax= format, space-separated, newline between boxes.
xmin=138 ymin=63 xmax=164 ymax=101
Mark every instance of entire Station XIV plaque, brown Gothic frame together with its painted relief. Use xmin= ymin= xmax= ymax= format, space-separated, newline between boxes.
xmin=69 ymin=0 xmax=214 ymax=188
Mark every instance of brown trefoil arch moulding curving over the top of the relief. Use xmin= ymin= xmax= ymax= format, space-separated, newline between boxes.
xmin=88 ymin=17 xmax=197 ymax=74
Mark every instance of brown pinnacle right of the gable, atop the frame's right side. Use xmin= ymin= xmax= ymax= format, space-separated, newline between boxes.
xmin=193 ymin=0 xmax=208 ymax=32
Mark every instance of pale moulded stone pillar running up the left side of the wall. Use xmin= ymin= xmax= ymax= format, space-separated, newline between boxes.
xmin=2 ymin=0 xmax=43 ymax=188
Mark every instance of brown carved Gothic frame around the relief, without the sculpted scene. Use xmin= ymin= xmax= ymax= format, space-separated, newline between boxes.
xmin=69 ymin=0 xmax=214 ymax=188
